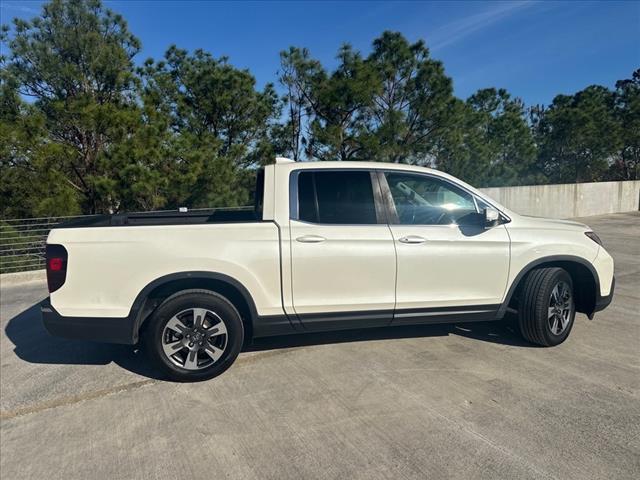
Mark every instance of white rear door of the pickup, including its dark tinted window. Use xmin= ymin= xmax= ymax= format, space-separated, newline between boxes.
xmin=289 ymin=169 xmax=396 ymax=329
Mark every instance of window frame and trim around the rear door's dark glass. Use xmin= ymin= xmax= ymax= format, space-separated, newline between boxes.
xmin=289 ymin=168 xmax=388 ymax=227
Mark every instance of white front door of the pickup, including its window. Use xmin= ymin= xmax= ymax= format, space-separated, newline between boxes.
xmin=380 ymin=171 xmax=509 ymax=323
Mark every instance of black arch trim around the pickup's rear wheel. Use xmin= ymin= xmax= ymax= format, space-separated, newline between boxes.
xmin=129 ymin=271 xmax=257 ymax=344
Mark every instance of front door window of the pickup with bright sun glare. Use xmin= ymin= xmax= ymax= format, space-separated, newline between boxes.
xmin=385 ymin=172 xmax=477 ymax=225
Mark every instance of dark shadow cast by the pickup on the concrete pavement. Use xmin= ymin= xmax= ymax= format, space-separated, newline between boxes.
xmin=5 ymin=303 xmax=535 ymax=379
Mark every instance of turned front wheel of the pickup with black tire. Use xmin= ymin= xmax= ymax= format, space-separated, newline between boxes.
xmin=518 ymin=267 xmax=576 ymax=347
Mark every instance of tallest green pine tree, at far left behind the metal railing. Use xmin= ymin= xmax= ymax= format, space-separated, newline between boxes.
xmin=1 ymin=0 xmax=140 ymax=213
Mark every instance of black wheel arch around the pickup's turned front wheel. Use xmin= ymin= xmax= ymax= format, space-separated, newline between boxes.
xmin=498 ymin=255 xmax=600 ymax=318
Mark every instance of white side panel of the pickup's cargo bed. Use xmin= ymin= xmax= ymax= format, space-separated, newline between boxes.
xmin=47 ymin=220 xmax=282 ymax=323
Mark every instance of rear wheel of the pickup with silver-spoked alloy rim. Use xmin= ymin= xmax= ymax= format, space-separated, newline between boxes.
xmin=143 ymin=290 xmax=244 ymax=382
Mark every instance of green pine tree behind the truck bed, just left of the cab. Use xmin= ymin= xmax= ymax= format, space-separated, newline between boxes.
xmin=141 ymin=47 xmax=279 ymax=207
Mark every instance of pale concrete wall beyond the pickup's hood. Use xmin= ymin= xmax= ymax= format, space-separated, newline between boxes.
xmin=481 ymin=180 xmax=640 ymax=218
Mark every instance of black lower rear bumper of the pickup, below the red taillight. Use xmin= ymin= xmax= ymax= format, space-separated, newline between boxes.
xmin=40 ymin=299 xmax=134 ymax=345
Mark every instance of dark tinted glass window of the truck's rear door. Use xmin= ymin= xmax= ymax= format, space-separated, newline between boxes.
xmin=298 ymin=170 xmax=378 ymax=225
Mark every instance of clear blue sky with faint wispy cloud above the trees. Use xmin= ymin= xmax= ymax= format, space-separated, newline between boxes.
xmin=0 ymin=0 xmax=640 ymax=105
